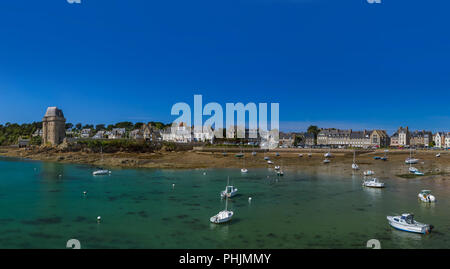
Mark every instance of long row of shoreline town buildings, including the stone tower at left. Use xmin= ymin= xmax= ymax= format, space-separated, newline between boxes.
xmin=33 ymin=107 xmax=450 ymax=148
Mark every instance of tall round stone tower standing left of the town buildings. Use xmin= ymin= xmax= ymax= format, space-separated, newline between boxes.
xmin=42 ymin=107 xmax=66 ymax=145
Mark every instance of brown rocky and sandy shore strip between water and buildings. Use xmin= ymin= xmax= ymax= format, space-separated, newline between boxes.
xmin=0 ymin=147 xmax=450 ymax=180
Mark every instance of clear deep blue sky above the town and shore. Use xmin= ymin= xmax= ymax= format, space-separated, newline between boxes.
xmin=0 ymin=0 xmax=450 ymax=131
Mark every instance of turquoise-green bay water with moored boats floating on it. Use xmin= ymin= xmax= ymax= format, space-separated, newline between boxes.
xmin=0 ymin=158 xmax=450 ymax=248
